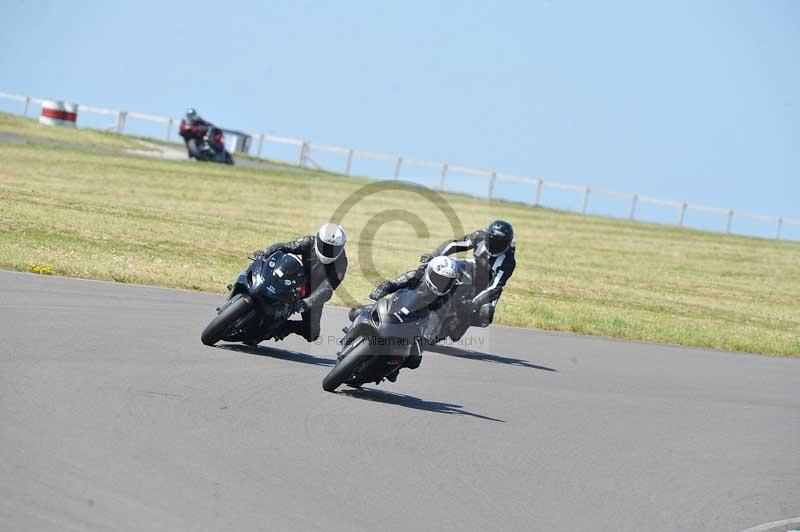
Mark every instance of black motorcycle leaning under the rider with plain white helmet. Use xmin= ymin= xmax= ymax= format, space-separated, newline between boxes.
xmin=200 ymin=251 xmax=307 ymax=345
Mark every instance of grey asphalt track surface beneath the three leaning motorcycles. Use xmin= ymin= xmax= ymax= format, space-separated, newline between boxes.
xmin=0 ymin=272 xmax=800 ymax=532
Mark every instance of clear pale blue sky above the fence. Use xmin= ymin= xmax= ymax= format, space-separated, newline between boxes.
xmin=0 ymin=0 xmax=800 ymax=235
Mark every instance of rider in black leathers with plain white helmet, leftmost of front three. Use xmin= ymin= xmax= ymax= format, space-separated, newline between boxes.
xmin=253 ymin=223 xmax=347 ymax=342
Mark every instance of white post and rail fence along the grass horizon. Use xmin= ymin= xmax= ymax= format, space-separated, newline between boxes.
xmin=0 ymin=92 xmax=800 ymax=239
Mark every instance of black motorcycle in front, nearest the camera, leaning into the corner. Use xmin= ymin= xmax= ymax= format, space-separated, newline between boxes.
xmin=322 ymin=289 xmax=431 ymax=392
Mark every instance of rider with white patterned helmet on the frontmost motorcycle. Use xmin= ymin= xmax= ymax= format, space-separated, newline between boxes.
xmin=360 ymin=256 xmax=458 ymax=382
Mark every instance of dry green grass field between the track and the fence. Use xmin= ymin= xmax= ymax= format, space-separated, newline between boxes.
xmin=0 ymin=115 xmax=800 ymax=356
